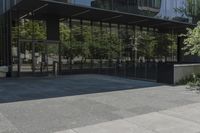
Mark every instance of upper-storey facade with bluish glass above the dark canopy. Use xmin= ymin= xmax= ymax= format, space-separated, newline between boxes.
xmin=53 ymin=0 xmax=200 ymax=23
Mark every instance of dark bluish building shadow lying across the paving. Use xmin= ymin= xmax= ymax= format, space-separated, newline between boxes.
xmin=0 ymin=75 xmax=162 ymax=103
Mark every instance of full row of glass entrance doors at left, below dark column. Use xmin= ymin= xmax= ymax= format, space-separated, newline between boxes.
xmin=13 ymin=40 xmax=59 ymax=76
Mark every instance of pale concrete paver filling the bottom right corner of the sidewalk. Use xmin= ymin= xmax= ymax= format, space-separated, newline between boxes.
xmin=127 ymin=112 xmax=200 ymax=133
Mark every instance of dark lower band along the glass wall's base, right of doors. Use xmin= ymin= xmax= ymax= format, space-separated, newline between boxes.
xmin=61 ymin=59 xmax=158 ymax=80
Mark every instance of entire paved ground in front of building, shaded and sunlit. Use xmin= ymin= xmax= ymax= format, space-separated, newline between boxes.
xmin=0 ymin=75 xmax=200 ymax=133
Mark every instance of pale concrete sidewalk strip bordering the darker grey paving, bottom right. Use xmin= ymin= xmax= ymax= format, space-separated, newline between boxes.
xmin=56 ymin=103 xmax=200 ymax=133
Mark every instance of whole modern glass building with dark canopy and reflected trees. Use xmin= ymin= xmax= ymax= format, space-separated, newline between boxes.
xmin=0 ymin=0 xmax=200 ymax=83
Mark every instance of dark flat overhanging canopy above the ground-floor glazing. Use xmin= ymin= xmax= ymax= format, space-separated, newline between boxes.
xmin=12 ymin=0 xmax=196 ymax=33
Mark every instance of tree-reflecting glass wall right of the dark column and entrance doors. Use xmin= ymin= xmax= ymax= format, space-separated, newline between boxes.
xmin=57 ymin=19 xmax=177 ymax=80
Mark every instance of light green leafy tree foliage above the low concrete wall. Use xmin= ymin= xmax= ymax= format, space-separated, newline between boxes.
xmin=181 ymin=22 xmax=200 ymax=56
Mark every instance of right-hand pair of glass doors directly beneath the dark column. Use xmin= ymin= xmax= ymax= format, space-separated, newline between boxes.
xmin=34 ymin=41 xmax=59 ymax=76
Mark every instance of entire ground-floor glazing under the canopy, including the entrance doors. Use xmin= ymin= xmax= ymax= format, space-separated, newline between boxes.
xmin=7 ymin=16 xmax=177 ymax=80
